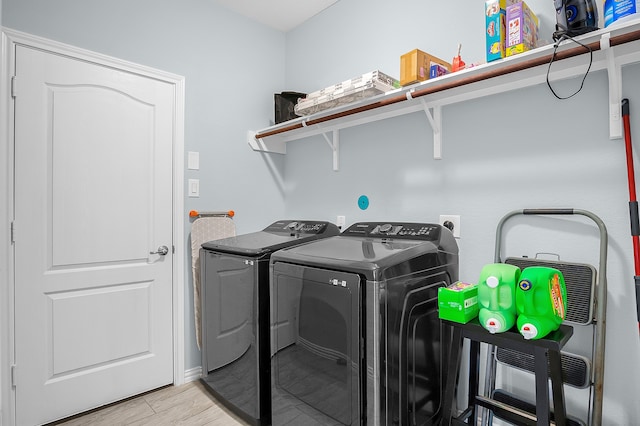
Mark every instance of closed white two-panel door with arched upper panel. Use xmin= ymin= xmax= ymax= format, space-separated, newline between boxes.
xmin=14 ymin=45 xmax=175 ymax=425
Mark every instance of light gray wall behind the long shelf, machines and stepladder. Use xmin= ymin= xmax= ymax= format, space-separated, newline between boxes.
xmin=285 ymin=0 xmax=640 ymax=425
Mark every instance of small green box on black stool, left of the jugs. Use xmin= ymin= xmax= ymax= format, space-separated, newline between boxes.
xmin=438 ymin=281 xmax=480 ymax=324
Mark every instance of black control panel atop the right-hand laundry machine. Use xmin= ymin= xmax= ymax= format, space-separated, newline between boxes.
xmin=341 ymin=222 xmax=442 ymax=241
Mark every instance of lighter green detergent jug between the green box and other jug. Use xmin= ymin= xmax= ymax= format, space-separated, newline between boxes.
xmin=478 ymin=263 xmax=520 ymax=334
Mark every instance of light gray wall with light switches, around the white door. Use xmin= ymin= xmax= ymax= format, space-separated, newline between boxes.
xmin=2 ymin=0 xmax=285 ymax=369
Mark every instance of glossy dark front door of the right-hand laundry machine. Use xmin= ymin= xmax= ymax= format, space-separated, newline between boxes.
xmin=272 ymin=262 xmax=364 ymax=425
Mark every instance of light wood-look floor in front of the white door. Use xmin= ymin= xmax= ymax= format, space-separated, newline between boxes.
xmin=49 ymin=381 xmax=248 ymax=426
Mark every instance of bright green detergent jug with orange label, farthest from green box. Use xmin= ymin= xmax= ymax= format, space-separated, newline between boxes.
xmin=516 ymin=266 xmax=567 ymax=340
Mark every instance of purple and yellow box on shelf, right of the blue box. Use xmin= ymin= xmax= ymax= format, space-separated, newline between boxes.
xmin=506 ymin=1 xmax=538 ymax=56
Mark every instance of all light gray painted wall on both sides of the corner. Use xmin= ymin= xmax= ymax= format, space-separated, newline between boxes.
xmin=2 ymin=0 xmax=640 ymax=425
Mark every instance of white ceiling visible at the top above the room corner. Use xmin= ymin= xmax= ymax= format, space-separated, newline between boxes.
xmin=215 ymin=0 xmax=338 ymax=32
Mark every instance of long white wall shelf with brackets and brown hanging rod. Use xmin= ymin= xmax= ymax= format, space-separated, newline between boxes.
xmin=247 ymin=20 xmax=640 ymax=166
